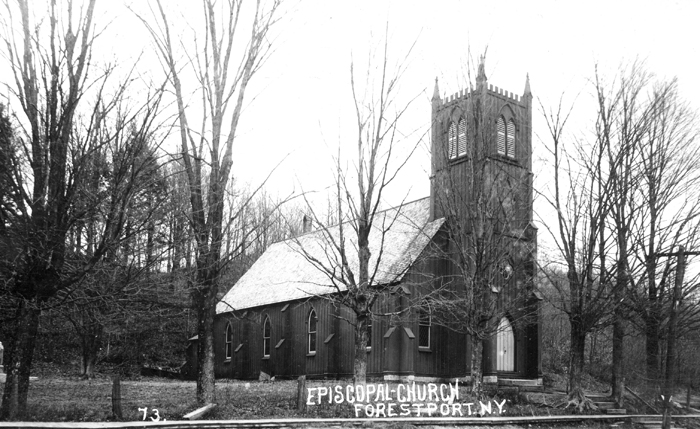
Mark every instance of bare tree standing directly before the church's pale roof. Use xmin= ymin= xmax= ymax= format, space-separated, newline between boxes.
xmin=294 ymin=35 xmax=419 ymax=384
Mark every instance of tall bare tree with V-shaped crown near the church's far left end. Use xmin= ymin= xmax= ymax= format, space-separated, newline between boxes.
xmin=142 ymin=0 xmax=280 ymax=403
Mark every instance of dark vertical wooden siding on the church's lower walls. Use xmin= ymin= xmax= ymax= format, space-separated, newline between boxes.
xmin=208 ymin=227 xmax=539 ymax=379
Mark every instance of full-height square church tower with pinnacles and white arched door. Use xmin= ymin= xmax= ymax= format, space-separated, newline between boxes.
xmin=430 ymin=57 xmax=541 ymax=382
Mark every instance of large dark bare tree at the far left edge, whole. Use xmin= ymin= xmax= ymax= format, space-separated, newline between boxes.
xmin=1 ymin=1 xmax=165 ymax=418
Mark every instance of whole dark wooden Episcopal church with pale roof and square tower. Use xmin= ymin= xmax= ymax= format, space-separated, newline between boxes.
xmin=189 ymin=60 xmax=541 ymax=384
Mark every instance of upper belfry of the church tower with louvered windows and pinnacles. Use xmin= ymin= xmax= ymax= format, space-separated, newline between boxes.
xmin=430 ymin=58 xmax=533 ymax=228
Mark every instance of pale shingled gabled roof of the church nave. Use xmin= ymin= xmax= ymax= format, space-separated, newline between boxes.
xmin=216 ymin=198 xmax=444 ymax=314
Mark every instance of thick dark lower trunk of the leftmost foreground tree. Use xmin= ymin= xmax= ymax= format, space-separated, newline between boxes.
xmin=0 ymin=301 xmax=41 ymax=420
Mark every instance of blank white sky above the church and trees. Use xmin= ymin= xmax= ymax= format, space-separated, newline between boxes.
xmin=0 ymin=0 xmax=700 ymax=258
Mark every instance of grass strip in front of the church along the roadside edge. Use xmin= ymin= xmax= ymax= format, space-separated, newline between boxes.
xmin=0 ymin=376 xmax=660 ymax=427
